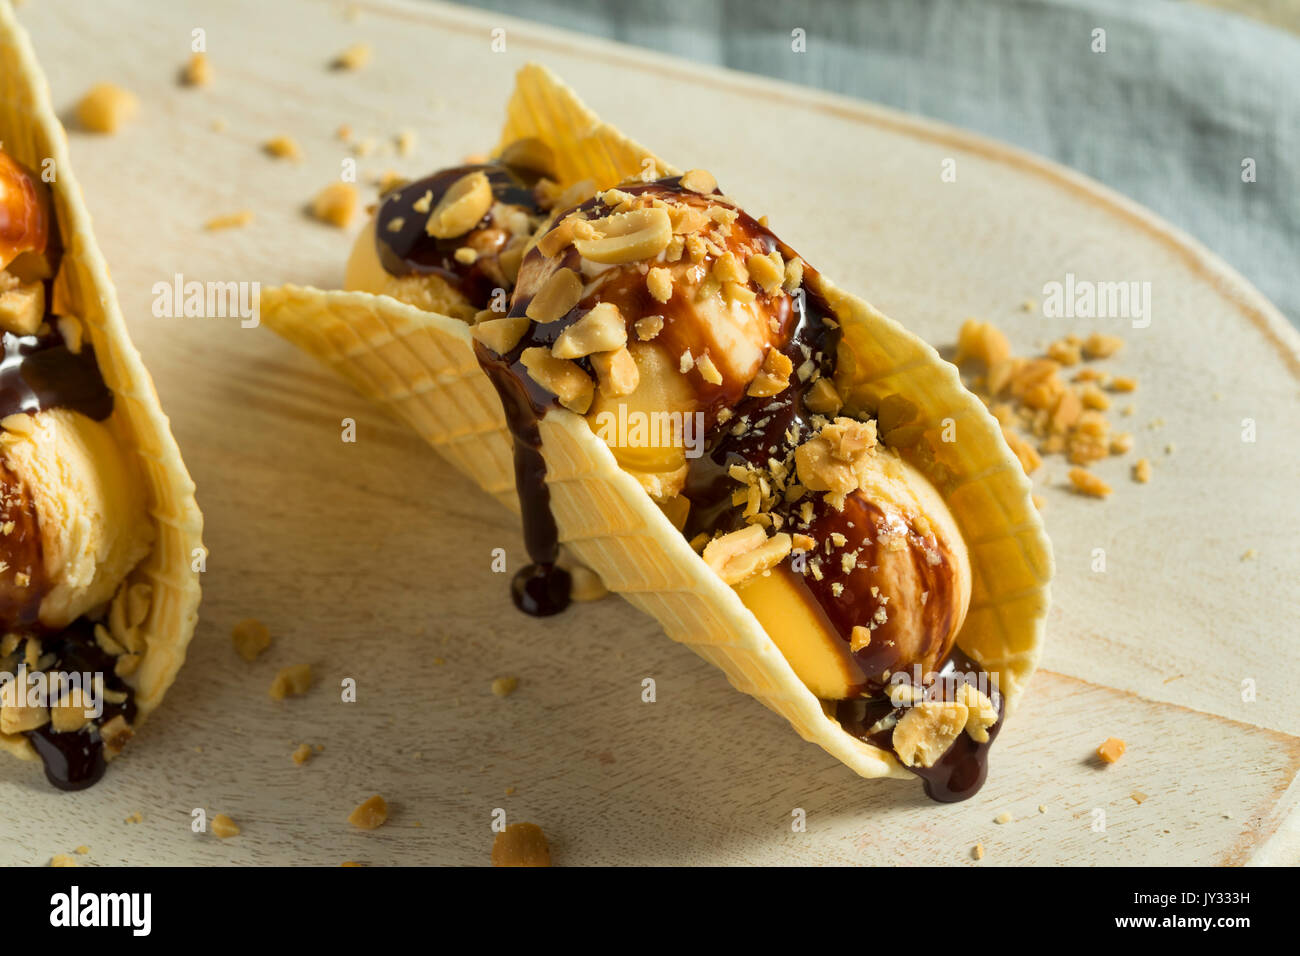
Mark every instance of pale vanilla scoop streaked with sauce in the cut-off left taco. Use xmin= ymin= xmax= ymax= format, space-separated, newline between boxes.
xmin=0 ymin=408 xmax=153 ymax=628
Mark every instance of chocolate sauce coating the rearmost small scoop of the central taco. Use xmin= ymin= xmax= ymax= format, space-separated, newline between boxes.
xmin=374 ymin=163 xmax=545 ymax=308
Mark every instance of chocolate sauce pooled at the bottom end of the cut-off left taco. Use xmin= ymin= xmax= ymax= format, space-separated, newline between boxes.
xmin=10 ymin=618 xmax=135 ymax=791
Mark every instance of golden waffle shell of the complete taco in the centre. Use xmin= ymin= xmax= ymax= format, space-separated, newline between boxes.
xmin=263 ymin=65 xmax=1053 ymax=777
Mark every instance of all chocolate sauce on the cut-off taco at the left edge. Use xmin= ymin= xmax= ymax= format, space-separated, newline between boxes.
xmin=0 ymin=153 xmax=122 ymax=790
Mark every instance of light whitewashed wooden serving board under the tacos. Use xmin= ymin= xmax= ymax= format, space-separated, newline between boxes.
xmin=0 ymin=0 xmax=1300 ymax=866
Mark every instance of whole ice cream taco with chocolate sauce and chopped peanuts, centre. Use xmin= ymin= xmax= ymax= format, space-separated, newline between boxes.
xmin=263 ymin=66 xmax=1052 ymax=800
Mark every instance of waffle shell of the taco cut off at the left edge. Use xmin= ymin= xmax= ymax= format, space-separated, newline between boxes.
xmin=0 ymin=0 xmax=203 ymax=760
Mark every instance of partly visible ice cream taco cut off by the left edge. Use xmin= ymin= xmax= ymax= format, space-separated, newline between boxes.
xmin=0 ymin=0 xmax=203 ymax=790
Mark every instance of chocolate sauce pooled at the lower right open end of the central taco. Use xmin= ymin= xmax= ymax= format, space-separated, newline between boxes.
xmin=835 ymin=648 xmax=1006 ymax=804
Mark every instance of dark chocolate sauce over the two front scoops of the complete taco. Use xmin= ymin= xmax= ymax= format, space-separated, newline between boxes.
xmin=476 ymin=177 xmax=1002 ymax=803
